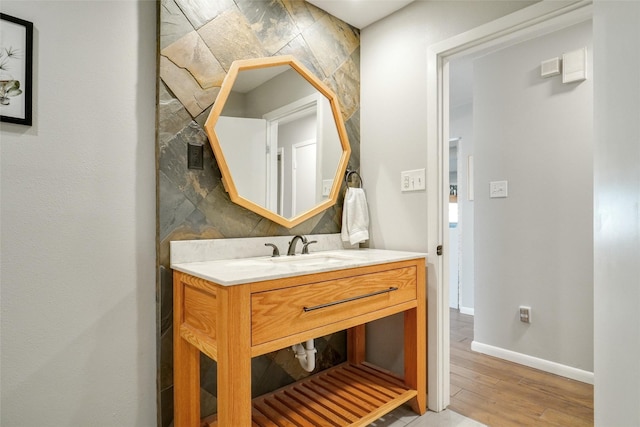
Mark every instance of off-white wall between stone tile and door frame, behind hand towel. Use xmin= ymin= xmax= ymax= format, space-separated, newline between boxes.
xmin=360 ymin=1 xmax=531 ymax=371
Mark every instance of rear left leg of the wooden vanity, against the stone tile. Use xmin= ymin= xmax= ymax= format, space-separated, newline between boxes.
xmin=173 ymin=274 xmax=200 ymax=427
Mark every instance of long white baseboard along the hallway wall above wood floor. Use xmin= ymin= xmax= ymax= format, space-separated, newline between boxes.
xmin=470 ymin=342 xmax=593 ymax=384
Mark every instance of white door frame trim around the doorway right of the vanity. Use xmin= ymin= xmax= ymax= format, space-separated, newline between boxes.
xmin=427 ymin=0 xmax=593 ymax=412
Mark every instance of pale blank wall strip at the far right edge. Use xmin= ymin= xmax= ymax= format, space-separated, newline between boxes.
xmin=593 ymin=0 xmax=640 ymax=427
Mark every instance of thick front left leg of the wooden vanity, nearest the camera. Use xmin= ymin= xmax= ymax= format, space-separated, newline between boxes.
xmin=217 ymin=286 xmax=251 ymax=426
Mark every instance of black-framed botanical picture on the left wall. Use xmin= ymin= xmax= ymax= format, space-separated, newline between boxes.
xmin=0 ymin=13 xmax=33 ymax=126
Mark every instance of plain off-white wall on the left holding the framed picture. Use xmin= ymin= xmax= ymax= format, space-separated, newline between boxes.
xmin=0 ymin=0 xmax=156 ymax=427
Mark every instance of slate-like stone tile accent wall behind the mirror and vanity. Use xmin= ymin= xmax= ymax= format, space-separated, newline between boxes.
xmin=157 ymin=0 xmax=360 ymax=426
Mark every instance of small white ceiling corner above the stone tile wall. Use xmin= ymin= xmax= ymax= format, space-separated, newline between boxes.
xmin=307 ymin=0 xmax=414 ymax=29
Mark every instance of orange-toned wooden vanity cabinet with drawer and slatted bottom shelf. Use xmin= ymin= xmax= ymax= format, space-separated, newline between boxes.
xmin=173 ymin=258 xmax=427 ymax=427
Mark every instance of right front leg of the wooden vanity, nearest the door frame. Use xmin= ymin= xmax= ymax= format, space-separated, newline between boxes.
xmin=404 ymin=268 xmax=427 ymax=415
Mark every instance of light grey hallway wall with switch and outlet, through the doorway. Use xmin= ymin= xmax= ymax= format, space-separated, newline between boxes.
xmin=472 ymin=22 xmax=593 ymax=372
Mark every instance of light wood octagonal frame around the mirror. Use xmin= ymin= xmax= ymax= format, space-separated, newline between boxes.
xmin=204 ymin=55 xmax=351 ymax=228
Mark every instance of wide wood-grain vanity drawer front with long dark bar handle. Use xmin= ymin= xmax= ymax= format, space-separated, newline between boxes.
xmin=251 ymin=266 xmax=417 ymax=346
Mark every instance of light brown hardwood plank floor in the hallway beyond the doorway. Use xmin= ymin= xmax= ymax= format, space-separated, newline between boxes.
xmin=449 ymin=309 xmax=593 ymax=427
